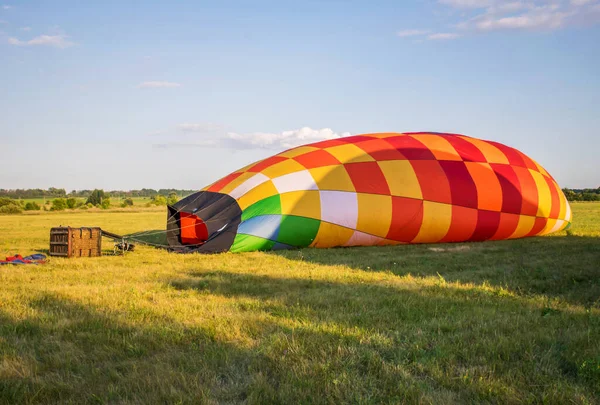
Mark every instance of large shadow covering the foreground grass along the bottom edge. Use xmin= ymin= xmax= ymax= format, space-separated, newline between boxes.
xmin=0 ymin=271 xmax=600 ymax=403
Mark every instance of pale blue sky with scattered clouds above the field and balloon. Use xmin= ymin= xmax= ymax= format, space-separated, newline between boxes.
xmin=0 ymin=0 xmax=600 ymax=190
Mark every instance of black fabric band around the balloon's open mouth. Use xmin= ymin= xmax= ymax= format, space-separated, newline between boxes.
xmin=167 ymin=191 xmax=242 ymax=253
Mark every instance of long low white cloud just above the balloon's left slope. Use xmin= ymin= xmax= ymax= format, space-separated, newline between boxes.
xmin=154 ymin=123 xmax=351 ymax=150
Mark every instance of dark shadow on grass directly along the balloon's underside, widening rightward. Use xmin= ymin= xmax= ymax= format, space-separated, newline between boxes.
xmin=269 ymin=236 xmax=600 ymax=307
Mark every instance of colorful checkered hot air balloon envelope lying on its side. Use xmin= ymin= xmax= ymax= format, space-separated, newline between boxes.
xmin=167 ymin=133 xmax=572 ymax=252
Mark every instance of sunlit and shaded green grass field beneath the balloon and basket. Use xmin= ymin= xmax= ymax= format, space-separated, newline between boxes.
xmin=0 ymin=203 xmax=600 ymax=404
